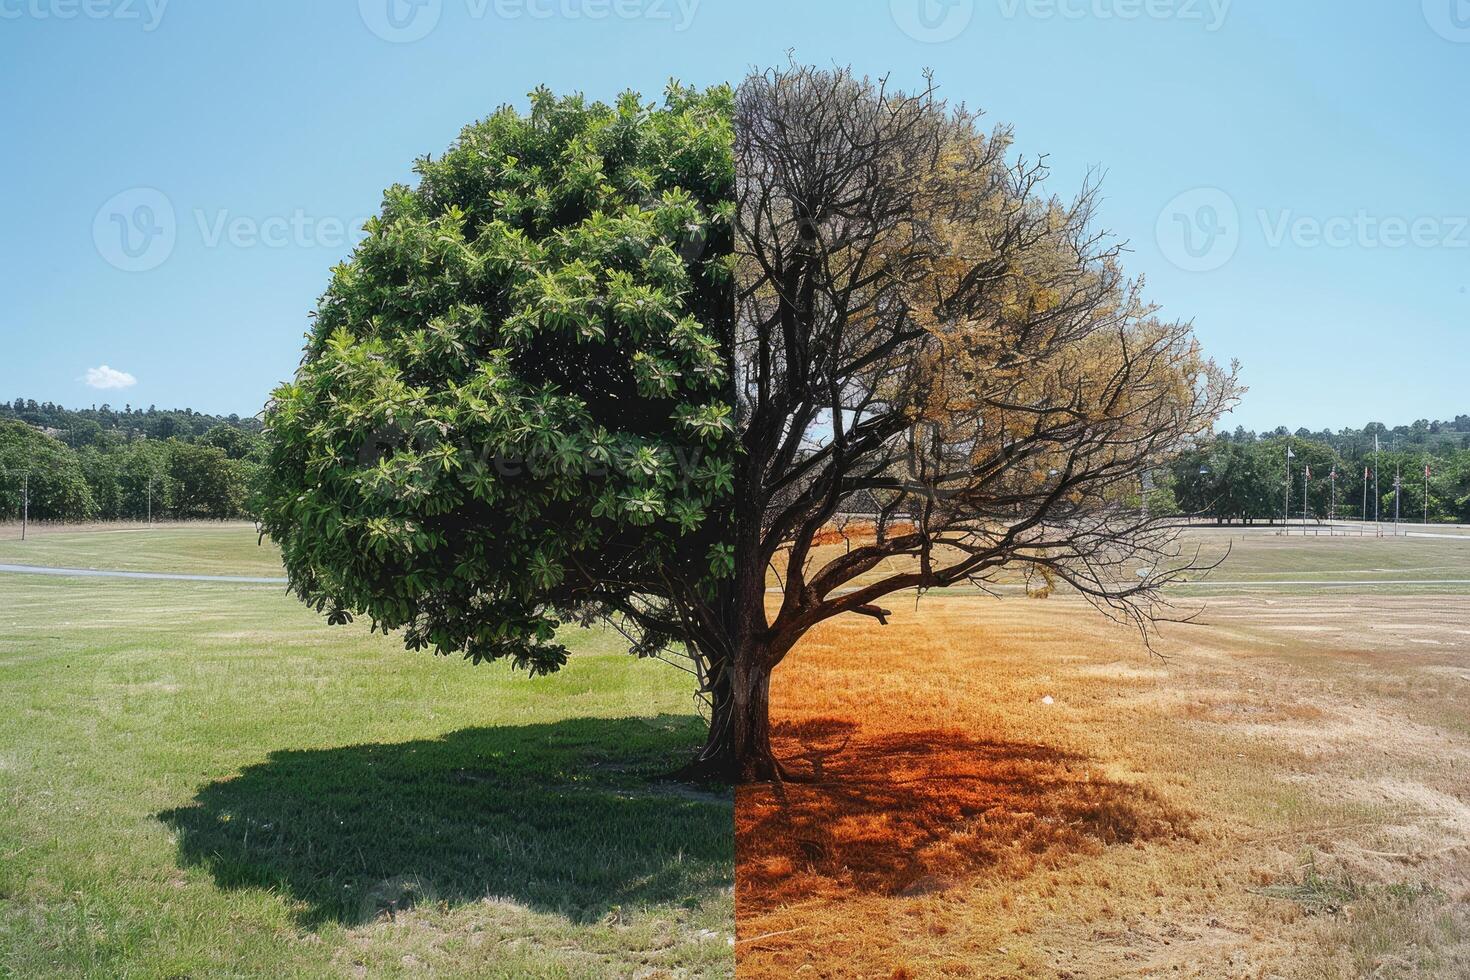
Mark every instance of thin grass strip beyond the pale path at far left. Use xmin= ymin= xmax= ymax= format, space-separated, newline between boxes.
xmin=0 ymin=523 xmax=285 ymax=577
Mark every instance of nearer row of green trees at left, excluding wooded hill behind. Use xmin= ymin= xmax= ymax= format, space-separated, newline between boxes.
xmin=0 ymin=422 xmax=263 ymax=520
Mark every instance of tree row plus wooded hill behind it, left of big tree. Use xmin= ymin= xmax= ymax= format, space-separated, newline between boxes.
xmin=0 ymin=398 xmax=265 ymax=520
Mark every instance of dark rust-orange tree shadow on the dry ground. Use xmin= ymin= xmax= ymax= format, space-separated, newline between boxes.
xmin=735 ymin=718 xmax=1189 ymax=915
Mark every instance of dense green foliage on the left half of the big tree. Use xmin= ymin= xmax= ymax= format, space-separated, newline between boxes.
xmin=260 ymin=87 xmax=735 ymax=671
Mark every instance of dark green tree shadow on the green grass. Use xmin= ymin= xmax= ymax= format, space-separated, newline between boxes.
xmin=159 ymin=716 xmax=734 ymax=926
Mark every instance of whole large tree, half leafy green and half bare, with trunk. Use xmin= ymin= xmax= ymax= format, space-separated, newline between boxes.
xmin=260 ymin=68 xmax=1236 ymax=780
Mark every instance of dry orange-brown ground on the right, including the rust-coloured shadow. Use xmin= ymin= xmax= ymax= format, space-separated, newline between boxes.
xmin=736 ymin=594 xmax=1470 ymax=980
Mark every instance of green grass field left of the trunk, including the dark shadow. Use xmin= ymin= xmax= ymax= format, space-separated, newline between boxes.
xmin=0 ymin=529 xmax=734 ymax=977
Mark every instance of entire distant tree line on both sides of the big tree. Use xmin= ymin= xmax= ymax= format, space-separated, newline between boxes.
xmin=0 ymin=398 xmax=1470 ymax=523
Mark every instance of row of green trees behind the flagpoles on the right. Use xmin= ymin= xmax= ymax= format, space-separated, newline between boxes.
xmin=1167 ymin=435 xmax=1470 ymax=523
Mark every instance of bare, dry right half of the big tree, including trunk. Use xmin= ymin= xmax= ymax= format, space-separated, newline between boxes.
xmin=694 ymin=65 xmax=1239 ymax=782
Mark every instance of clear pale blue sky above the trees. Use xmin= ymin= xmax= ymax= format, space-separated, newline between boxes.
xmin=0 ymin=0 xmax=1470 ymax=429
